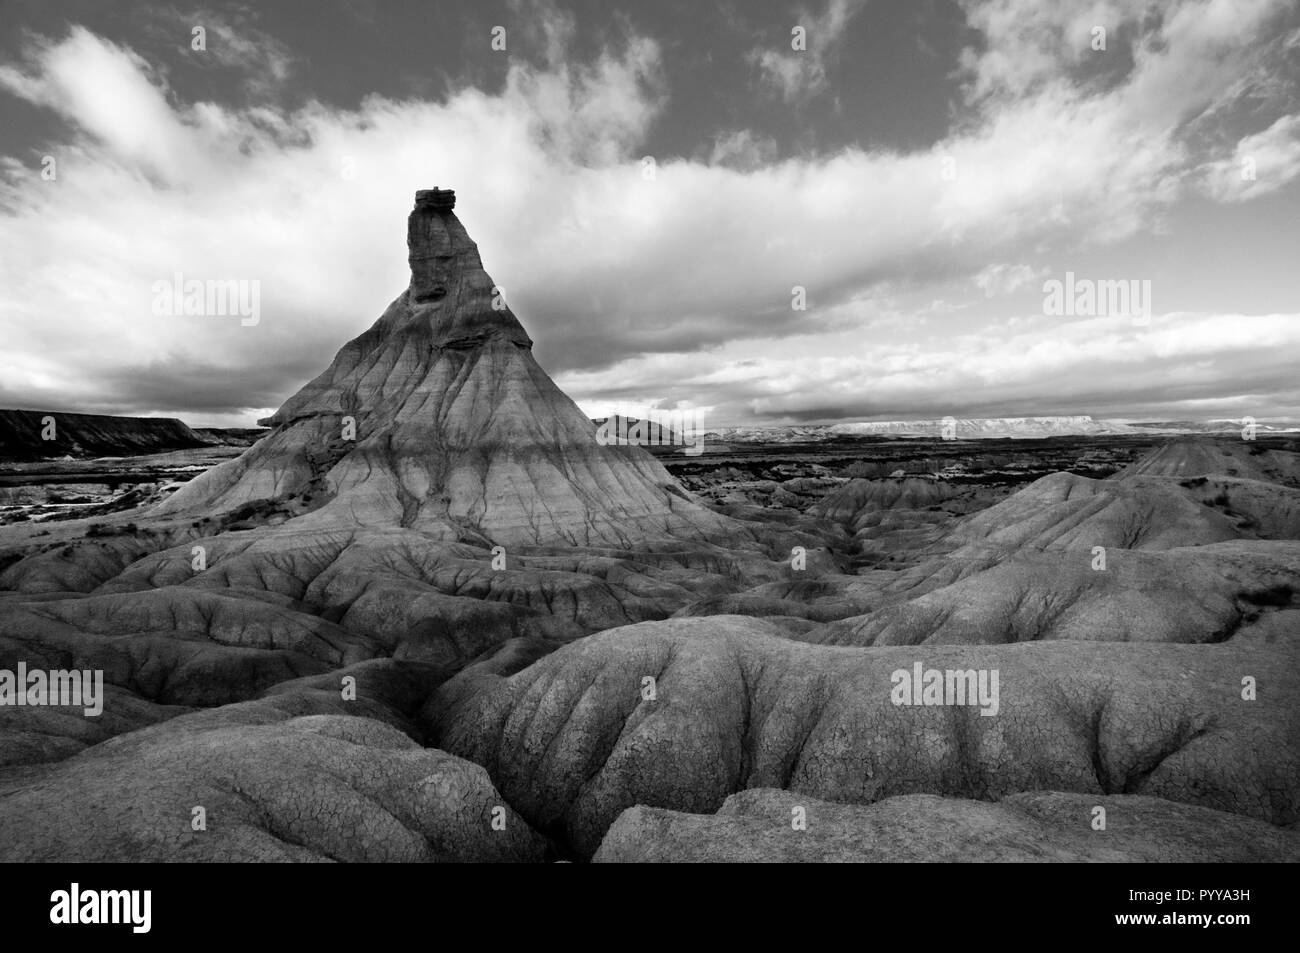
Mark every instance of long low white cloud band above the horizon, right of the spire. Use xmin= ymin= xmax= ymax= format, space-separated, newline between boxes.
xmin=559 ymin=312 xmax=1300 ymax=425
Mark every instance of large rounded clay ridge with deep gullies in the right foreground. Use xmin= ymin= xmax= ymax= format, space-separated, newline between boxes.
xmin=429 ymin=616 xmax=1300 ymax=855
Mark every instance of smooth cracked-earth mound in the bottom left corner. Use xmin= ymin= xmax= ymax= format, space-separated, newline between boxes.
xmin=0 ymin=667 xmax=549 ymax=862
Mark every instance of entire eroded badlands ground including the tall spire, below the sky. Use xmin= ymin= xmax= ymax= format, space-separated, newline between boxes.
xmin=0 ymin=190 xmax=1300 ymax=862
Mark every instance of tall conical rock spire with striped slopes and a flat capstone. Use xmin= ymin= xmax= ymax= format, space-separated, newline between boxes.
xmin=160 ymin=189 xmax=744 ymax=545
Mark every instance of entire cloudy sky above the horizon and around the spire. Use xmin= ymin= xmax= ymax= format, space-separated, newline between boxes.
xmin=0 ymin=0 xmax=1300 ymax=426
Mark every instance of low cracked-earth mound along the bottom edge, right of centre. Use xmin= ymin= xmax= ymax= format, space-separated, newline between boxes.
xmin=592 ymin=788 xmax=1300 ymax=863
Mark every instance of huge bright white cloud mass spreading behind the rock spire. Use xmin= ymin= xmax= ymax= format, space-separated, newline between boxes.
xmin=0 ymin=0 xmax=1295 ymax=420
